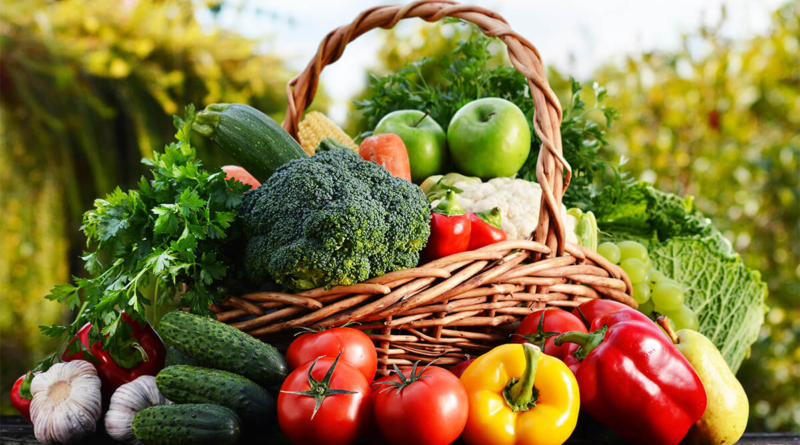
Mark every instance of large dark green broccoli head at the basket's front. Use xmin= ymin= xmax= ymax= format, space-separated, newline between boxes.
xmin=240 ymin=139 xmax=431 ymax=291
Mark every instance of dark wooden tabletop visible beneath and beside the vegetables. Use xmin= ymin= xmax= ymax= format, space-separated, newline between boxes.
xmin=0 ymin=416 xmax=800 ymax=445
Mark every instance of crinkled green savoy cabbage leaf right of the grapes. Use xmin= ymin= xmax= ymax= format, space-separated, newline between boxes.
xmin=592 ymin=182 xmax=767 ymax=372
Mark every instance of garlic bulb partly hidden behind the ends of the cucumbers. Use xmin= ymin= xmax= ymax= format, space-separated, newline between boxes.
xmin=105 ymin=375 xmax=172 ymax=444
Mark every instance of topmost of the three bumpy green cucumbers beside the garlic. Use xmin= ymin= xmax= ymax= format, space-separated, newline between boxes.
xmin=160 ymin=311 xmax=288 ymax=388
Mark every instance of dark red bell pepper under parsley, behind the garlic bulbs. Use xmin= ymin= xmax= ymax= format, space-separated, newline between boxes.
xmin=61 ymin=314 xmax=167 ymax=401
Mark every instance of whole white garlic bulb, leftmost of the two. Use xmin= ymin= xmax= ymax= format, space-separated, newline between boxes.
xmin=31 ymin=360 xmax=103 ymax=445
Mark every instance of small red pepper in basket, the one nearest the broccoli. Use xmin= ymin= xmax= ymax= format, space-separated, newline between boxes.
xmin=420 ymin=190 xmax=472 ymax=263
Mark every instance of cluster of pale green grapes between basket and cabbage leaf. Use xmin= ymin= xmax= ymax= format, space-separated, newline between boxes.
xmin=597 ymin=241 xmax=700 ymax=331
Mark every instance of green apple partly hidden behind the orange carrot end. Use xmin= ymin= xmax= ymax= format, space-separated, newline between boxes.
xmin=372 ymin=110 xmax=447 ymax=184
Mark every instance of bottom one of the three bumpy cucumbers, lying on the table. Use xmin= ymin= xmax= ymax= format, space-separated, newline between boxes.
xmin=131 ymin=404 xmax=241 ymax=445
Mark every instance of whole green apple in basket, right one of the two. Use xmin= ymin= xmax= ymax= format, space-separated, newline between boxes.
xmin=447 ymin=97 xmax=531 ymax=179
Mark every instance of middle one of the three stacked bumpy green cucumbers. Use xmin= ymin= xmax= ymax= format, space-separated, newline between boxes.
xmin=156 ymin=365 xmax=275 ymax=425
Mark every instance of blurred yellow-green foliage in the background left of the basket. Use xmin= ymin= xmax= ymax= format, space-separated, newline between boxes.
xmin=0 ymin=0 xmax=326 ymax=414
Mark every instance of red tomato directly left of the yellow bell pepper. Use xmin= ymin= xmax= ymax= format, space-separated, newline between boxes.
xmin=375 ymin=366 xmax=469 ymax=445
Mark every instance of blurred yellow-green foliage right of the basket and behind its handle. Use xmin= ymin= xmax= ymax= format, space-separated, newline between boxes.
xmin=348 ymin=2 xmax=800 ymax=431
